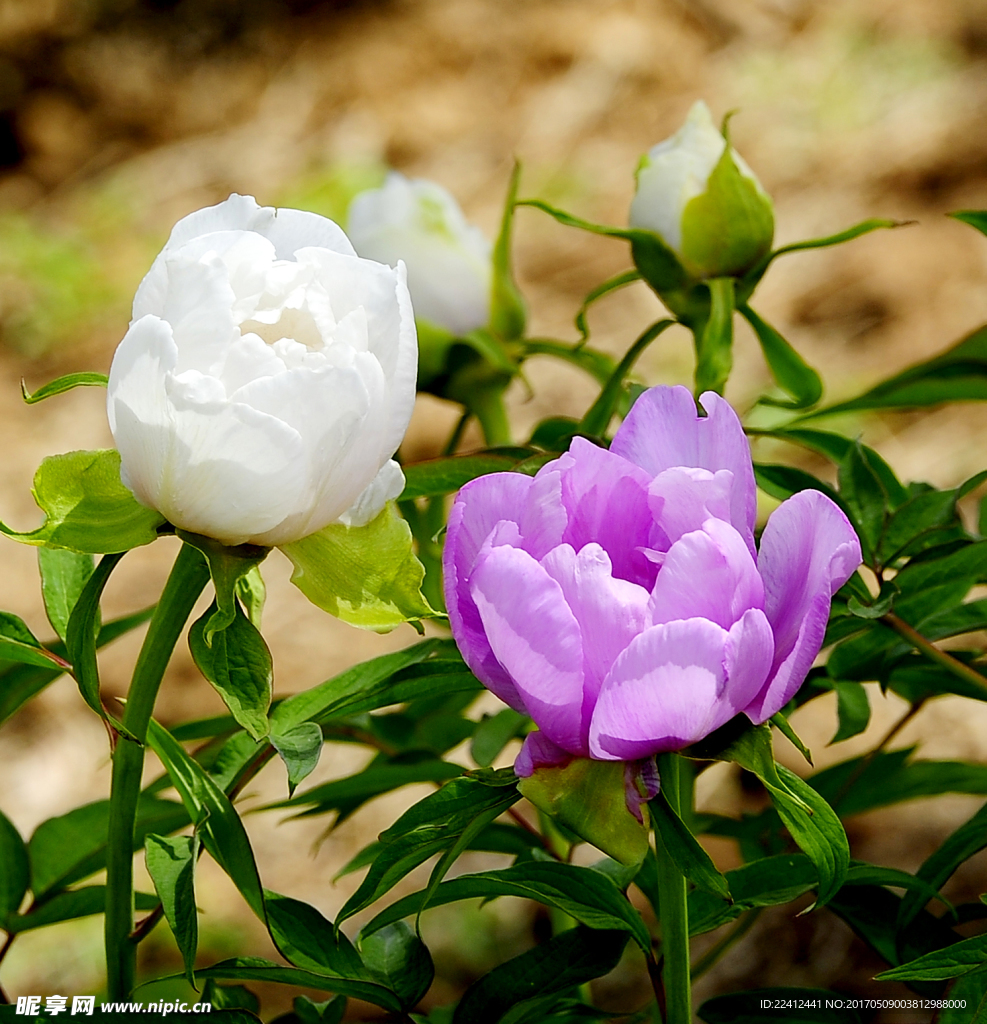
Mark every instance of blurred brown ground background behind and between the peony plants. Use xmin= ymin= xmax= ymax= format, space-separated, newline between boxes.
xmin=0 ymin=0 xmax=987 ymax=1019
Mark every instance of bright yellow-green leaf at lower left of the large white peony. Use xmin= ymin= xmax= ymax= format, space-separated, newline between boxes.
xmin=0 ymin=449 xmax=165 ymax=555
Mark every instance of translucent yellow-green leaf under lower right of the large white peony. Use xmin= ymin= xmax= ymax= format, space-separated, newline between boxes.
xmin=282 ymin=502 xmax=435 ymax=632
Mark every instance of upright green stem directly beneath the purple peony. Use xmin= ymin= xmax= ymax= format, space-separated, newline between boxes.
xmin=654 ymin=754 xmax=692 ymax=1024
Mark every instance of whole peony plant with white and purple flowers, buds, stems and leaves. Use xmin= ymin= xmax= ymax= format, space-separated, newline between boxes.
xmin=0 ymin=104 xmax=987 ymax=1024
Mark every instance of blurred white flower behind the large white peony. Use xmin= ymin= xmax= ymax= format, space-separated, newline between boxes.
xmin=347 ymin=172 xmax=492 ymax=337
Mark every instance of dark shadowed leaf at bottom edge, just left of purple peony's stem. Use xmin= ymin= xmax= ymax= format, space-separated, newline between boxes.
xmin=453 ymin=928 xmax=627 ymax=1024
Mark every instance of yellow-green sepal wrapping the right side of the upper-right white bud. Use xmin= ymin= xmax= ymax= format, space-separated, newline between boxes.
xmin=680 ymin=143 xmax=774 ymax=279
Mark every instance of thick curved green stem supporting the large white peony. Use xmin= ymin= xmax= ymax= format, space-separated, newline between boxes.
xmin=104 ymin=544 xmax=209 ymax=1000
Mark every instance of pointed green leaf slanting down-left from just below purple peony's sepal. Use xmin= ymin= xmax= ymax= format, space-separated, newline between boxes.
xmin=336 ymin=772 xmax=519 ymax=925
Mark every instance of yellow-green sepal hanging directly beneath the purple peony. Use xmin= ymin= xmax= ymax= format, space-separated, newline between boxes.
xmin=518 ymin=758 xmax=648 ymax=864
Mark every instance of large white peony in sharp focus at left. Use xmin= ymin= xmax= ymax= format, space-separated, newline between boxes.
xmin=106 ymin=195 xmax=417 ymax=547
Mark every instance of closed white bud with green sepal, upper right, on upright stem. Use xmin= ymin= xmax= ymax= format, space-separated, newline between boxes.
xmin=630 ymin=100 xmax=774 ymax=280
